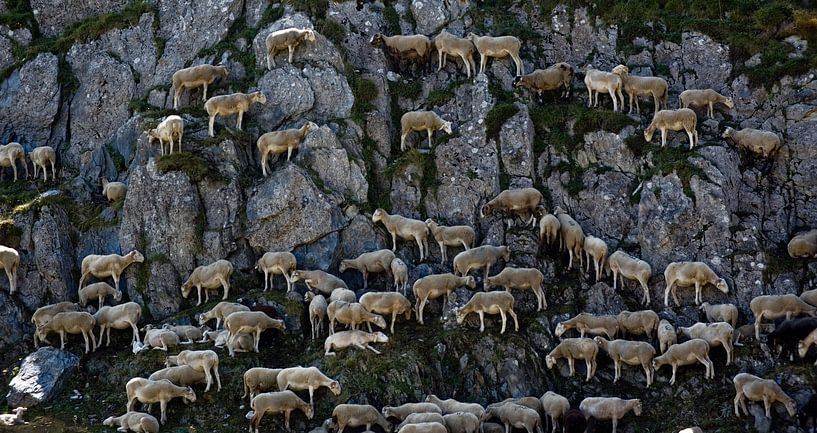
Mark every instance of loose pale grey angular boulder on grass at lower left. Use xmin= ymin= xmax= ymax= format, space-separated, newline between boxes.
xmin=6 ymin=347 xmax=79 ymax=407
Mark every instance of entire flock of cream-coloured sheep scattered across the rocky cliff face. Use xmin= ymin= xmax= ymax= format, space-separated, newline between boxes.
xmin=0 ymin=11 xmax=817 ymax=433
